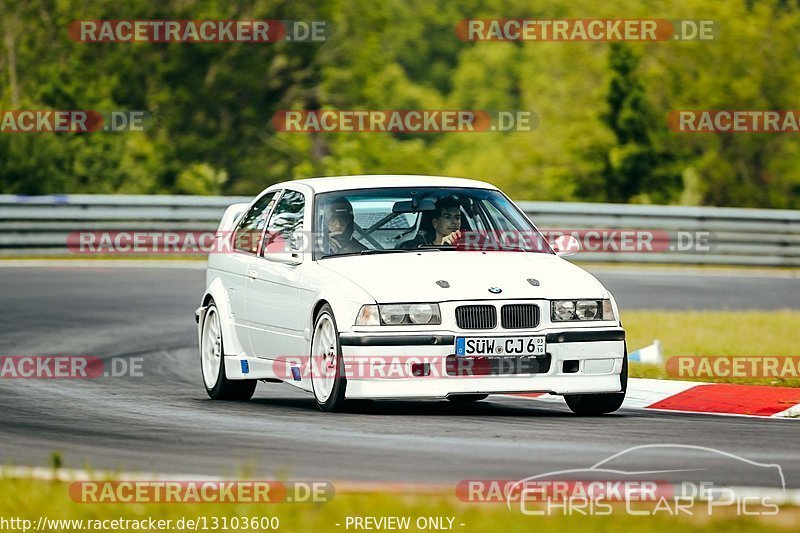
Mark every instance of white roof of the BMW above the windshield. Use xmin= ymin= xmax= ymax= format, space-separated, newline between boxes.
xmin=262 ymin=174 xmax=497 ymax=194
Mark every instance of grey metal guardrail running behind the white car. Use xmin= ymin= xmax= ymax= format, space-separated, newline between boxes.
xmin=0 ymin=194 xmax=800 ymax=266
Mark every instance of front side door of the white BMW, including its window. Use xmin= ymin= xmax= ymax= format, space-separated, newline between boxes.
xmin=247 ymin=189 xmax=308 ymax=359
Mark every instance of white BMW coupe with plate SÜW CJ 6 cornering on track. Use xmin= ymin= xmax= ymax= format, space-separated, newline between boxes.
xmin=195 ymin=176 xmax=628 ymax=415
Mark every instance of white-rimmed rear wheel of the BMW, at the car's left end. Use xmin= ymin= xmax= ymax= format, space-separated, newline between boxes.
xmin=200 ymin=300 xmax=258 ymax=401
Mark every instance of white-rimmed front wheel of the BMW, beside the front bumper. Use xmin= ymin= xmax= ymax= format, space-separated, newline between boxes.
xmin=309 ymin=304 xmax=347 ymax=412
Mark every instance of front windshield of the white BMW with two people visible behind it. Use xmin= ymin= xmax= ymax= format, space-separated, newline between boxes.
xmin=314 ymin=187 xmax=553 ymax=259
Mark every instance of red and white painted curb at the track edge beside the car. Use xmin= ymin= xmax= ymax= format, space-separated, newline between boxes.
xmin=514 ymin=378 xmax=800 ymax=420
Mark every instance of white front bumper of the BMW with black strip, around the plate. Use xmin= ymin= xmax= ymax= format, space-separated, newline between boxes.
xmin=339 ymin=328 xmax=625 ymax=399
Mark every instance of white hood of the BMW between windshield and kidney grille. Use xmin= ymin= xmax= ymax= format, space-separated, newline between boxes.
xmin=319 ymin=251 xmax=607 ymax=303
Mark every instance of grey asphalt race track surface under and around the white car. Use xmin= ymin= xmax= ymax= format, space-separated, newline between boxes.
xmin=0 ymin=267 xmax=800 ymax=487
